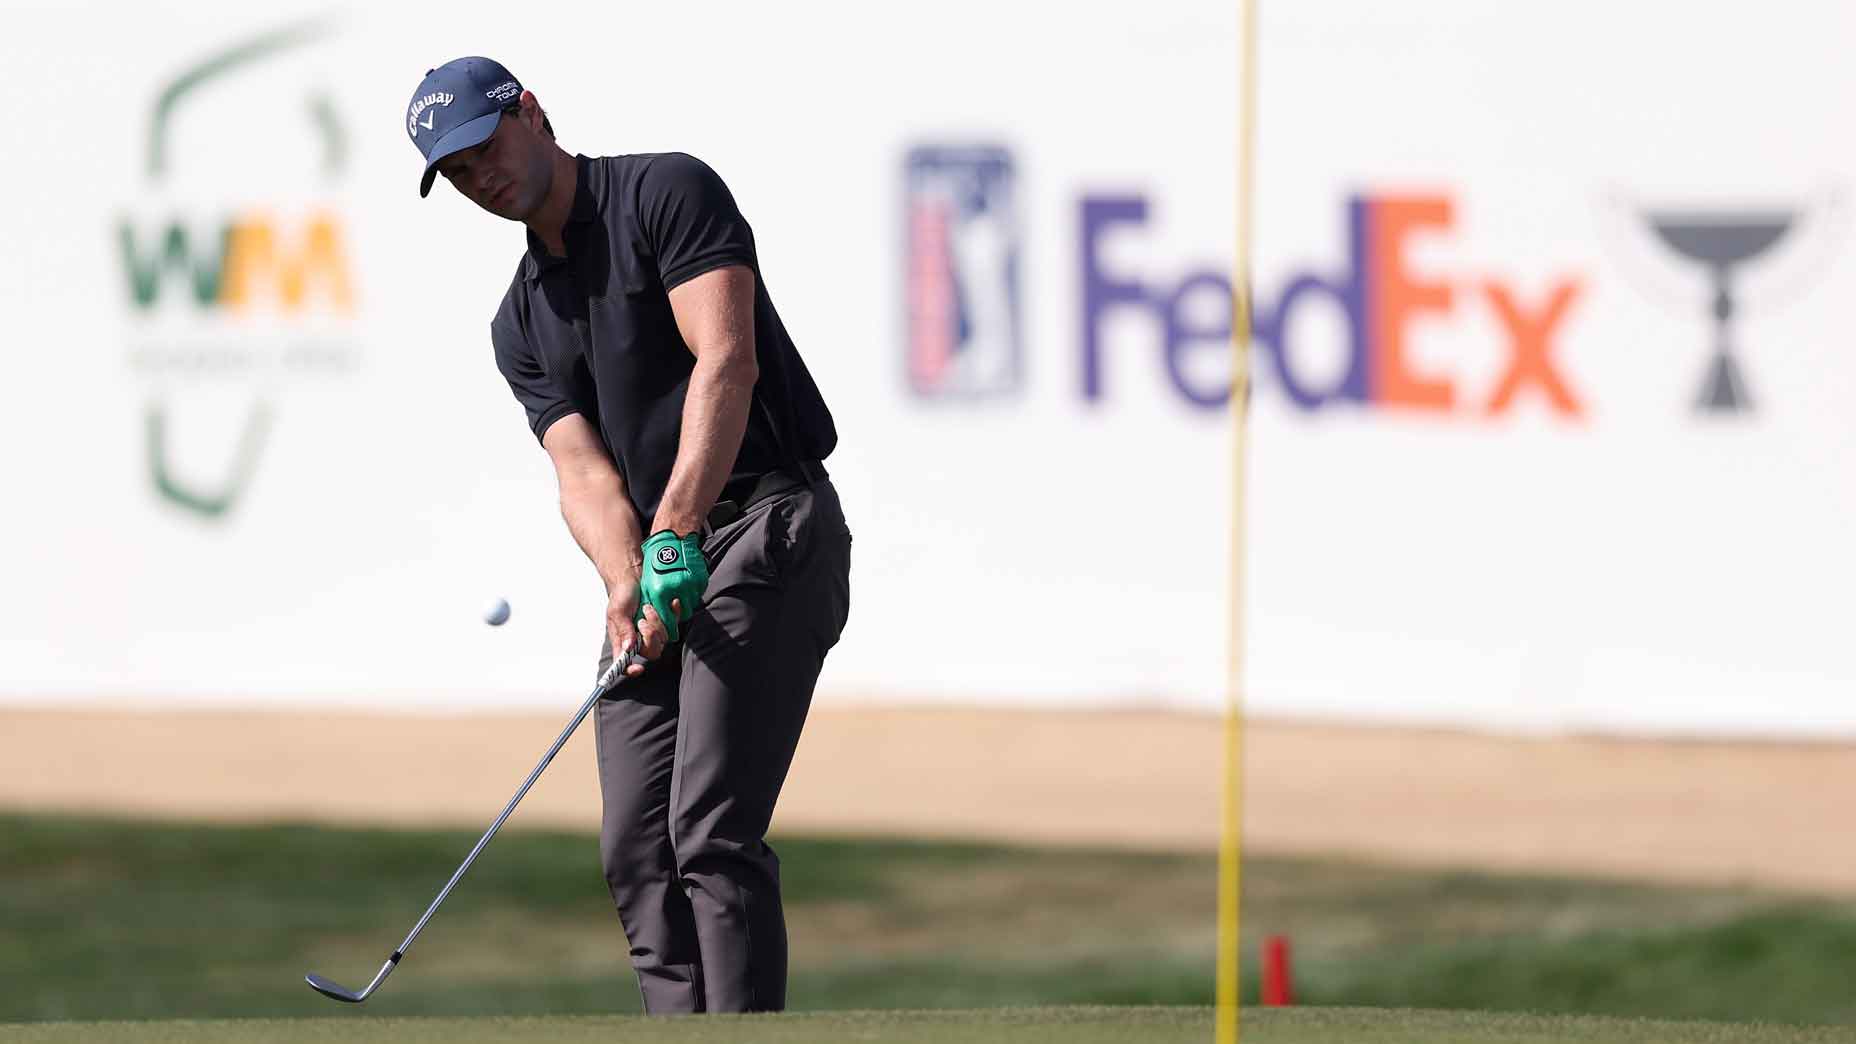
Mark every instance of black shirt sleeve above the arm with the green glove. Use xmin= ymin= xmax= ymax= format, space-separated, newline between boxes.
xmin=638 ymin=152 xmax=754 ymax=290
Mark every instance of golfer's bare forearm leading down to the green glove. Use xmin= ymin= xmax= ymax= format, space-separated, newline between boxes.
xmin=651 ymin=354 xmax=757 ymax=535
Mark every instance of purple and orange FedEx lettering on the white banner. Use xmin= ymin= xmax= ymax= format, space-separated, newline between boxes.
xmin=1082 ymin=195 xmax=1585 ymax=418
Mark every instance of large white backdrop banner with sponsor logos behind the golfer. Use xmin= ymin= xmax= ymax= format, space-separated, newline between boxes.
xmin=0 ymin=0 xmax=1856 ymax=734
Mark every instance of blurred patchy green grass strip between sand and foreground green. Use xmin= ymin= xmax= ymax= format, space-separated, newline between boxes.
xmin=0 ymin=816 xmax=1856 ymax=1017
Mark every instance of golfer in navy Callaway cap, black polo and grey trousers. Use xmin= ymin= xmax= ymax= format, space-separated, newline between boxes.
xmin=406 ymin=58 xmax=850 ymax=1012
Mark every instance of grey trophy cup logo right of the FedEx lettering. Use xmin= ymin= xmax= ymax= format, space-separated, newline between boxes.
xmin=1624 ymin=193 xmax=1841 ymax=416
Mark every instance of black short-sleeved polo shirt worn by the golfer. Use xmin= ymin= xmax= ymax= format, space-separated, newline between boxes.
xmin=490 ymin=152 xmax=837 ymax=526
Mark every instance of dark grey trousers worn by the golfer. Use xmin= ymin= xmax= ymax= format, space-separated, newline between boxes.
xmin=594 ymin=479 xmax=850 ymax=1014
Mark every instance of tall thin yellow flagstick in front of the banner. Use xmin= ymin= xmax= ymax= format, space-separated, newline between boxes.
xmin=1216 ymin=0 xmax=1260 ymax=1044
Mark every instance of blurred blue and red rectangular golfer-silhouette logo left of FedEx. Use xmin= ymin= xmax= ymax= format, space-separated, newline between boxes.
xmin=904 ymin=145 xmax=1025 ymax=398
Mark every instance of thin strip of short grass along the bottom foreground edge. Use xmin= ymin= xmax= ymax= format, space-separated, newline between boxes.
xmin=0 ymin=1007 xmax=1856 ymax=1044
